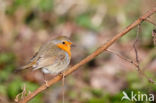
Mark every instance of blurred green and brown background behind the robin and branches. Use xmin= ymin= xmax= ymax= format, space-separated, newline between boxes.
xmin=0 ymin=0 xmax=156 ymax=103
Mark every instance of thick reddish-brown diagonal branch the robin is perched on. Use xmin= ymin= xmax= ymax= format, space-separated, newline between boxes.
xmin=19 ymin=8 xmax=156 ymax=103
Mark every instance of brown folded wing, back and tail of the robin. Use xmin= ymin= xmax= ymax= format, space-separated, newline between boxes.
xmin=22 ymin=43 xmax=66 ymax=70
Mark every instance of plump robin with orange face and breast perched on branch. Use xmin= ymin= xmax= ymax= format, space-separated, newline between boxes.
xmin=21 ymin=36 xmax=72 ymax=86
